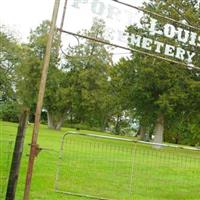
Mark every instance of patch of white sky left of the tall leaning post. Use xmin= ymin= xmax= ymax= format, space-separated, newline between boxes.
xmin=0 ymin=0 xmax=54 ymax=40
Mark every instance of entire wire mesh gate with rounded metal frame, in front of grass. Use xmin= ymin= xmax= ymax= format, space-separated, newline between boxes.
xmin=55 ymin=133 xmax=200 ymax=200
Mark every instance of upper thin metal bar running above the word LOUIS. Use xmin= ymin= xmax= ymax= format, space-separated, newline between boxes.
xmin=111 ymin=0 xmax=200 ymax=31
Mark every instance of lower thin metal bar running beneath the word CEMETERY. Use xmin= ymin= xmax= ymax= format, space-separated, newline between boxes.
xmin=58 ymin=29 xmax=200 ymax=70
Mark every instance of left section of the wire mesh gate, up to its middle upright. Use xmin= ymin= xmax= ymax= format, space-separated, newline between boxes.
xmin=56 ymin=134 xmax=134 ymax=200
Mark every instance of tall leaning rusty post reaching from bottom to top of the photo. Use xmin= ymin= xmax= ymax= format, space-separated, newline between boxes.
xmin=23 ymin=0 xmax=60 ymax=200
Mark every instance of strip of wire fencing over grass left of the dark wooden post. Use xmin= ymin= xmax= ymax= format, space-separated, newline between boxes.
xmin=0 ymin=140 xmax=13 ymax=199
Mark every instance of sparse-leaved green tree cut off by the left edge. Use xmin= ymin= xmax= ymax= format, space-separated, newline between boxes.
xmin=0 ymin=26 xmax=22 ymax=122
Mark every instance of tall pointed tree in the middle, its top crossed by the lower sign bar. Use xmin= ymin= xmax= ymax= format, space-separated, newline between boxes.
xmin=64 ymin=20 xmax=112 ymax=129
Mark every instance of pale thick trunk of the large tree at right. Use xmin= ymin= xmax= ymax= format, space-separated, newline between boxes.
xmin=154 ymin=114 xmax=164 ymax=144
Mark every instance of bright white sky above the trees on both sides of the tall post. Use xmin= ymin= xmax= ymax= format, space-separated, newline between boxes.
xmin=0 ymin=0 xmax=144 ymax=42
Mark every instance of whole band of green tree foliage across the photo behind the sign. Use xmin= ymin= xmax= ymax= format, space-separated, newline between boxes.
xmin=0 ymin=0 xmax=200 ymax=145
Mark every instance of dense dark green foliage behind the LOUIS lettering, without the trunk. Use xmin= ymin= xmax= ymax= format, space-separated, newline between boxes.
xmin=123 ymin=0 xmax=200 ymax=145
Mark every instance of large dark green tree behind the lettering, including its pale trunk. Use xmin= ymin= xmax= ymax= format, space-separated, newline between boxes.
xmin=124 ymin=0 xmax=200 ymax=143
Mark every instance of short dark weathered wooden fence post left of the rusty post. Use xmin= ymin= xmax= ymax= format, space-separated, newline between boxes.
xmin=6 ymin=109 xmax=29 ymax=200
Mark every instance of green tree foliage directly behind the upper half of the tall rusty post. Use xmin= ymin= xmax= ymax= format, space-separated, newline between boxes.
xmin=16 ymin=21 xmax=58 ymax=108
